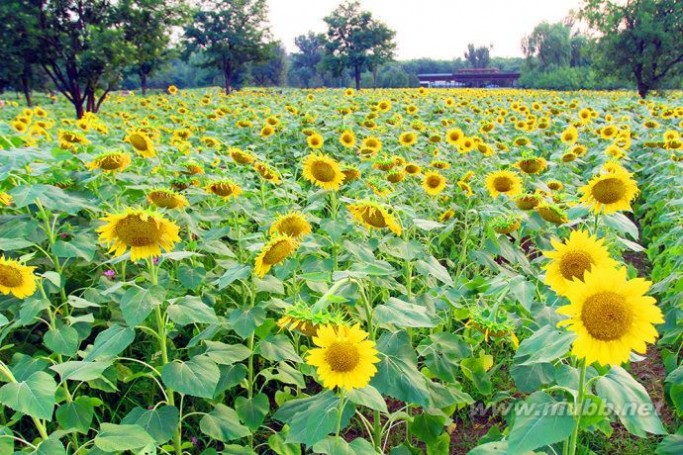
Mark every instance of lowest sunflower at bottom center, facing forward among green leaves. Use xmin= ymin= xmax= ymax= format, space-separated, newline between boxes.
xmin=306 ymin=324 xmax=379 ymax=390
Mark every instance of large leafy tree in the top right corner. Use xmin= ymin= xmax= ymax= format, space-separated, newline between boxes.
xmin=580 ymin=0 xmax=683 ymax=98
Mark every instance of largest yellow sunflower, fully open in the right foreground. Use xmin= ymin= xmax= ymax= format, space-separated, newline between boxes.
xmin=557 ymin=267 xmax=664 ymax=365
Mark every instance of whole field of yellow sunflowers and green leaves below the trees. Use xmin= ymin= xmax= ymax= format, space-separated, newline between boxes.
xmin=0 ymin=87 xmax=683 ymax=455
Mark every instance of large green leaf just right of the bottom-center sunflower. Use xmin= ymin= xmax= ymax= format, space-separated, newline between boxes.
xmin=370 ymin=331 xmax=429 ymax=406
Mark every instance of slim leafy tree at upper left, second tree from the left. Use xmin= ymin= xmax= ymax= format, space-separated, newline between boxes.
xmin=120 ymin=0 xmax=186 ymax=95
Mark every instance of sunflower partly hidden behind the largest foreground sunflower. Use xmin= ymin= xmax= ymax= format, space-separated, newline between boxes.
xmin=543 ymin=231 xmax=617 ymax=295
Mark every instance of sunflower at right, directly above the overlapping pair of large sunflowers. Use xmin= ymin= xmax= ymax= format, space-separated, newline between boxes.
xmin=580 ymin=171 xmax=638 ymax=215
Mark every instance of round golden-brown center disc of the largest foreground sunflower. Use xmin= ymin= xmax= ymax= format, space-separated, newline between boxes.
xmin=581 ymin=291 xmax=633 ymax=341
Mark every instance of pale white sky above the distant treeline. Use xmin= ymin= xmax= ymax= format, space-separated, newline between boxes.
xmin=268 ymin=0 xmax=581 ymax=60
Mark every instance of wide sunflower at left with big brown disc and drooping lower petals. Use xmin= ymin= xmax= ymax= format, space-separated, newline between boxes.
xmin=97 ymin=208 xmax=180 ymax=261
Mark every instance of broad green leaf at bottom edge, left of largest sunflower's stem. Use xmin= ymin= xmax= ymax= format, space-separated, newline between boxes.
xmin=508 ymin=392 xmax=574 ymax=453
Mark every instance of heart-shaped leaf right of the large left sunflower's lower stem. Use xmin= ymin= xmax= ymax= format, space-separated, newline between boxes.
xmin=161 ymin=355 xmax=221 ymax=398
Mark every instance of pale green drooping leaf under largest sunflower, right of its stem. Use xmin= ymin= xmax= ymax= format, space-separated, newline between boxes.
xmin=595 ymin=367 xmax=667 ymax=437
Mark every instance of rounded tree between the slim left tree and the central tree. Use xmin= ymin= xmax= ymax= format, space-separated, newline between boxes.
xmin=185 ymin=0 xmax=270 ymax=94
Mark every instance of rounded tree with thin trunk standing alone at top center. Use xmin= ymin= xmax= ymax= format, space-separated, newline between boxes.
xmin=323 ymin=0 xmax=396 ymax=90
